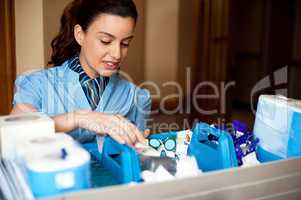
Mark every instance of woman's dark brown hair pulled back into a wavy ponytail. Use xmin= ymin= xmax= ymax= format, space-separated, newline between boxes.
xmin=48 ymin=0 xmax=138 ymax=66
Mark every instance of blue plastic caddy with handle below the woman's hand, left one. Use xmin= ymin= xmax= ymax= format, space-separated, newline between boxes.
xmin=82 ymin=137 xmax=141 ymax=187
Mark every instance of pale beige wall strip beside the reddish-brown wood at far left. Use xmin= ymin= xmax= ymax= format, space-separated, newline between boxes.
xmin=15 ymin=0 xmax=45 ymax=74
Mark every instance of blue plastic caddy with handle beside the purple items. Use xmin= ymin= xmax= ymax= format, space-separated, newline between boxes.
xmin=188 ymin=123 xmax=238 ymax=172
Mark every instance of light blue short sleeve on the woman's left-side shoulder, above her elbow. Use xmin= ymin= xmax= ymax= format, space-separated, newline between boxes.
xmin=13 ymin=75 xmax=41 ymax=110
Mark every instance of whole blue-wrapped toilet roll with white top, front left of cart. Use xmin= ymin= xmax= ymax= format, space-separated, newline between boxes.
xmin=20 ymin=133 xmax=90 ymax=197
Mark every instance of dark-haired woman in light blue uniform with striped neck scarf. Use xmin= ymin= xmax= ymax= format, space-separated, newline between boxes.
xmin=12 ymin=0 xmax=151 ymax=145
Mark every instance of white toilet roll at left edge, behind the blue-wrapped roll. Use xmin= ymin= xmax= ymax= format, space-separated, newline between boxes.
xmin=0 ymin=113 xmax=55 ymax=160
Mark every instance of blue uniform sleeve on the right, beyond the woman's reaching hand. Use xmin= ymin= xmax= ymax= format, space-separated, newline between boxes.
xmin=135 ymin=89 xmax=152 ymax=131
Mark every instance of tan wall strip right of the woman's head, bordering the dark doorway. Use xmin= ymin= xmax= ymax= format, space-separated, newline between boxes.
xmin=145 ymin=0 xmax=180 ymax=96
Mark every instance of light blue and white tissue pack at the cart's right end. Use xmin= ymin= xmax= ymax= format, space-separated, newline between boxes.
xmin=254 ymin=95 xmax=301 ymax=158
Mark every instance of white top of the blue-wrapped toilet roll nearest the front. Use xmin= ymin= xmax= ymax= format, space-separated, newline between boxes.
xmin=20 ymin=133 xmax=90 ymax=172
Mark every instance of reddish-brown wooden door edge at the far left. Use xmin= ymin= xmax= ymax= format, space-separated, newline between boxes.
xmin=0 ymin=0 xmax=16 ymax=115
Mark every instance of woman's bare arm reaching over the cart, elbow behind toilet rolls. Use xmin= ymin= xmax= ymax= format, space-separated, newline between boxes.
xmin=11 ymin=104 xmax=145 ymax=146
